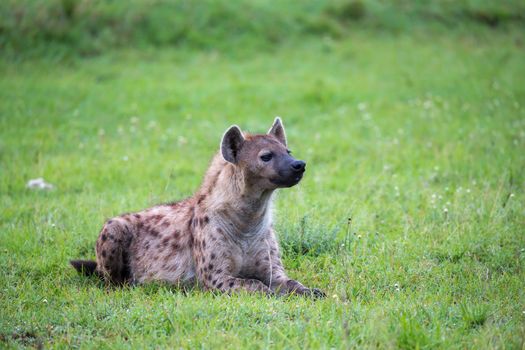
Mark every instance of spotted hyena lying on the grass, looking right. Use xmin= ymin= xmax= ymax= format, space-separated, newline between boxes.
xmin=71 ymin=117 xmax=324 ymax=297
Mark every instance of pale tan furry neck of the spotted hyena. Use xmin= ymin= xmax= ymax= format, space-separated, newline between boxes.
xmin=197 ymin=155 xmax=273 ymax=234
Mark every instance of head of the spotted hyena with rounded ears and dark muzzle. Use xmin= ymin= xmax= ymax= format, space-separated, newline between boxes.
xmin=221 ymin=117 xmax=306 ymax=190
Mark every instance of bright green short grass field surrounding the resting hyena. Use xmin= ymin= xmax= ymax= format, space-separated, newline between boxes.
xmin=0 ymin=27 xmax=525 ymax=349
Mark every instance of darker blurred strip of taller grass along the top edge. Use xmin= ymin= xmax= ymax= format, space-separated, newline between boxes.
xmin=0 ymin=0 xmax=525 ymax=55
